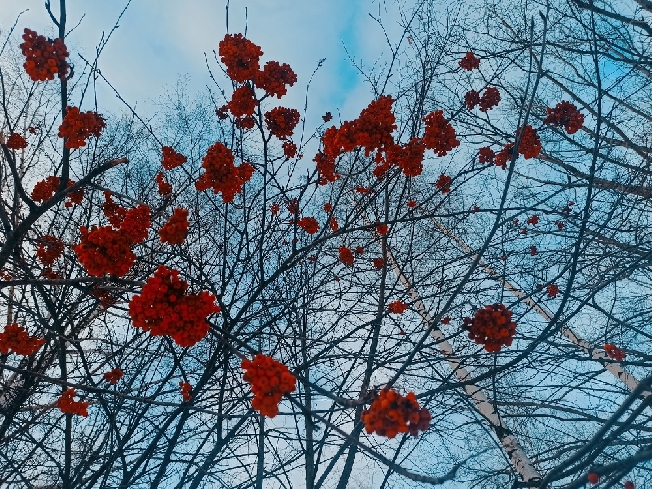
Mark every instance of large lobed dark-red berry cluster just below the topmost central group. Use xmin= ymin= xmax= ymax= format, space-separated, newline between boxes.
xmin=195 ymin=142 xmax=254 ymax=202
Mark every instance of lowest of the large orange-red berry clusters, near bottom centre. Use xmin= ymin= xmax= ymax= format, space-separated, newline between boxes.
xmin=361 ymin=387 xmax=432 ymax=438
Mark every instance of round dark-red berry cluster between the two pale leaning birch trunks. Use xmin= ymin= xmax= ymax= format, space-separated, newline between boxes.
xmin=462 ymin=304 xmax=516 ymax=353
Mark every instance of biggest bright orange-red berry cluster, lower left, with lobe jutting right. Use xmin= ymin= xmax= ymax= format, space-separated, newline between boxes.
xmin=129 ymin=265 xmax=221 ymax=347
